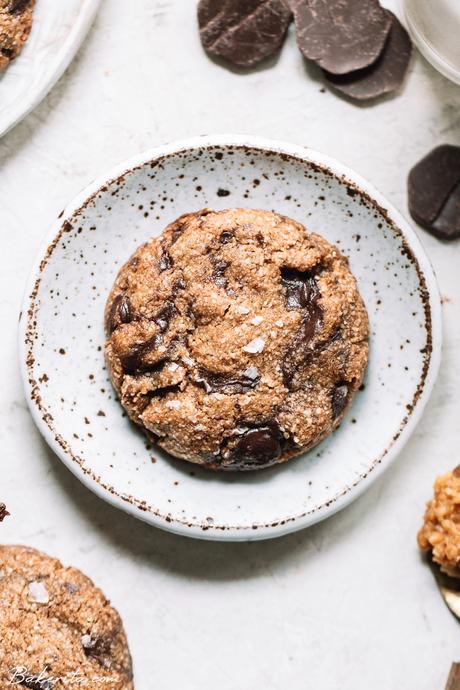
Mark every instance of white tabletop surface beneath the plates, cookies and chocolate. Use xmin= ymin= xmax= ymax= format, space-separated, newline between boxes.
xmin=0 ymin=0 xmax=460 ymax=690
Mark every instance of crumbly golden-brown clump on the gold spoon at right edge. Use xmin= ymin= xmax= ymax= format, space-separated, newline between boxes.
xmin=418 ymin=467 xmax=460 ymax=577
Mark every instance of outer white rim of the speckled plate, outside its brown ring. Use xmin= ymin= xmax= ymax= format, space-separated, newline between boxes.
xmin=19 ymin=134 xmax=442 ymax=541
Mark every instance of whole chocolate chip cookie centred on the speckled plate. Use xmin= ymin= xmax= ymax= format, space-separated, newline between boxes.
xmin=105 ymin=209 xmax=368 ymax=470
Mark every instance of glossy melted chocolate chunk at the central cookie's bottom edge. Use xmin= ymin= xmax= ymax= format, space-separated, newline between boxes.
xmin=232 ymin=419 xmax=283 ymax=468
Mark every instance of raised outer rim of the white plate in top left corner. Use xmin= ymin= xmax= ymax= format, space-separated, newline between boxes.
xmin=0 ymin=0 xmax=101 ymax=137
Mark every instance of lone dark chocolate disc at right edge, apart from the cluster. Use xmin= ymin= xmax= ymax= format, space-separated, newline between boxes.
xmin=408 ymin=144 xmax=460 ymax=240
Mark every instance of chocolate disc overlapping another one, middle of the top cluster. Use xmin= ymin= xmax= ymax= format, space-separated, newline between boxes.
xmin=290 ymin=0 xmax=392 ymax=74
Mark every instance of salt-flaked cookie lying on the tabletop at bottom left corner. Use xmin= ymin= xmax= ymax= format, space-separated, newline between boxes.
xmin=0 ymin=546 xmax=133 ymax=690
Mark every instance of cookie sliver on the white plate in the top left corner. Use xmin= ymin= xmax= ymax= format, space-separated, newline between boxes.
xmin=0 ymin=0 xmax=35 ymax=72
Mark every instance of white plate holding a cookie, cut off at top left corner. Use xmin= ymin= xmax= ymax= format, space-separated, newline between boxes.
xmin=0 ymin=0 xmax=100 ymax=136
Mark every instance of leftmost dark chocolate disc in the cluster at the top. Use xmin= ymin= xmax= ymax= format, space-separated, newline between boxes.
xmin=198 ymin=0 xmax=292 ymax=67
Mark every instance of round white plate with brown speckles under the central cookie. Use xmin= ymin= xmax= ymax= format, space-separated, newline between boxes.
xmin=20 ymin=136 xmax=441 ymax=540
